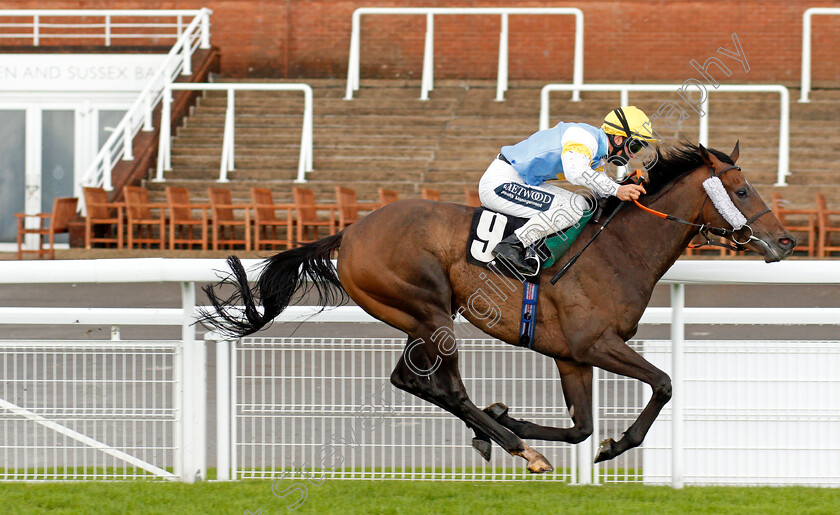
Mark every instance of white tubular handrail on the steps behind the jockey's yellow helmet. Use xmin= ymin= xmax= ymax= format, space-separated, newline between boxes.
xmin=540 ymin=84 xmax=790 ymax=186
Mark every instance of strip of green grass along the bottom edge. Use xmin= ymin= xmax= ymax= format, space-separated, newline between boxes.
xmin=0 ymin=480 xmax=840 ymax=515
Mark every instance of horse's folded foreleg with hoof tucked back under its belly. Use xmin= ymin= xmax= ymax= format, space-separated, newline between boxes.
xmin=484 ymin=359 xmax=592 ymax=443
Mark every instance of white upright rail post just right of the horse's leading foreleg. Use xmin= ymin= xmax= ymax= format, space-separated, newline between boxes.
xmin=671 ymin=283 xmax=685 ymax=488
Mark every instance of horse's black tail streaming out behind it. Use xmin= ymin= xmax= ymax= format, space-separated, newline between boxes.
xmin=198 ymin=233 xmax=347 ymax=338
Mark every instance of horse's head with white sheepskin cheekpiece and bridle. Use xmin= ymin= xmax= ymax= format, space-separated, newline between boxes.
xmin=699 ymin=143 xmax=796 ymax=263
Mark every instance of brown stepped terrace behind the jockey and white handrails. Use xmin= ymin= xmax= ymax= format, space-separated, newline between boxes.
xmin=146 ymin=80 xmax=840 ymax=207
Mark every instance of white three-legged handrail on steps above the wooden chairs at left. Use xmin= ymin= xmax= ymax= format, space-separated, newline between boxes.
xmin=155 ymin=82 xmax=313 ymax=182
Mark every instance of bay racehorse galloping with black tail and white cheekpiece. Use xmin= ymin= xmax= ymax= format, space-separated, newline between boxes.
xmin=200 ymin=143 xmax=795 ymax=472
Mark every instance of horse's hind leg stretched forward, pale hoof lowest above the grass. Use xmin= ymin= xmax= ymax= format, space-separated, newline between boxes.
xmin=391 ymin=317 xmax=554 ymax=473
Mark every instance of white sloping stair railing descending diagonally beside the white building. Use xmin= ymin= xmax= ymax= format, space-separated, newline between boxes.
xmin=76 ymin=8 xmax=212 ymax=197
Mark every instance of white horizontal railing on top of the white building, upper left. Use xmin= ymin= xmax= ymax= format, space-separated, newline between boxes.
xmin=0 ymin=9 xmax=208 ymax=46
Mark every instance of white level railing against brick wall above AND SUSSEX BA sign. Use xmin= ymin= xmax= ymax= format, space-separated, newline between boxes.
xmin=0 ymin=9 xmax=208 ymax=46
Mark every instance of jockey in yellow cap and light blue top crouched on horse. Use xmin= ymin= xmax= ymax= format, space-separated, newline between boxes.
xmin=478 ymin=106 xmax=659 ymax=276
